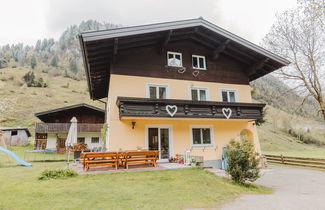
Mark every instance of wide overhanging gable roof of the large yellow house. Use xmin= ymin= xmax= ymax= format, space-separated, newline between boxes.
xmin=79 ymin=18 xmax=290 ymax=99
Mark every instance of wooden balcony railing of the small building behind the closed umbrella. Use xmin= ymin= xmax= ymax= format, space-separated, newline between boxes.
xmin=35 ymin=123 xmax=103 ymax=133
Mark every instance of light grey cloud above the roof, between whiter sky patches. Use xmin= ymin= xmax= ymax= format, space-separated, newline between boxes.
xmin=46 ymin=0 xmax=219 ymax=38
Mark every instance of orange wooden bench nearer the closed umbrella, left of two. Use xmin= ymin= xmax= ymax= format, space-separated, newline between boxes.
xmin=80 ymin=152 xmax=119 ymax=171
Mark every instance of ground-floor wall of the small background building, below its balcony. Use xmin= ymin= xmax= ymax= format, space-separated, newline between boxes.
xmin=46 ymin=132 xmax=102 ymax=149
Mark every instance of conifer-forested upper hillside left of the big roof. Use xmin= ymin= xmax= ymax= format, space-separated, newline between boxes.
xmin=0 ymin=20 xmax=118 ymax=80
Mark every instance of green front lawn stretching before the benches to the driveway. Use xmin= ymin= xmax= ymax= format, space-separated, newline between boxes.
xmin=0 ymin=163 xmax=271 ymax=209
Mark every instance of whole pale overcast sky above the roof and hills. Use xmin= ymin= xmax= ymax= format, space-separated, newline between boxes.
xmin=0 ymin=0 xmax=296 ymax=45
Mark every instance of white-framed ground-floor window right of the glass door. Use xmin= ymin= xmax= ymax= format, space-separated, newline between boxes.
xmin=191 ymin=126 xmax=212 ymax=146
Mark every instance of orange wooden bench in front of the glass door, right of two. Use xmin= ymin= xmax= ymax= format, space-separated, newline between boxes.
xmin=120 ymin=151 xmax=159 ymax=169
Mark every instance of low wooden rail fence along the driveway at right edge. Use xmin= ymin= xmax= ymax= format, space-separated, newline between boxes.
xmin=264 ymin=155 xmax=325 ymax=169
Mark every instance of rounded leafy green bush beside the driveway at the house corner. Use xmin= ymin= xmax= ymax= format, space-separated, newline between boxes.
xmin=226 ymin=138 xmax=260 ymax=184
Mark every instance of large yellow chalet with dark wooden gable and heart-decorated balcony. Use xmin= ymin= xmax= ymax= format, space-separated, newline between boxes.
xmin=79 ymin=18 xmax=289 ymax=168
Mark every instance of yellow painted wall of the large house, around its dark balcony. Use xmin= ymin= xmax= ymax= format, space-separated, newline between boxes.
xmin=107 ymin=74 xmax=260 ymax=160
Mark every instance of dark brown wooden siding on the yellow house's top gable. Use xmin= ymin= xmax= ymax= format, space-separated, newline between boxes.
xmin=111 ymin=40 xmax=249 ymax=85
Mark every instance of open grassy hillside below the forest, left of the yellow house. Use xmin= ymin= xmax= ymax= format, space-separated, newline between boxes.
xmin=0 ymin=67 xmax=104 ymax=133
